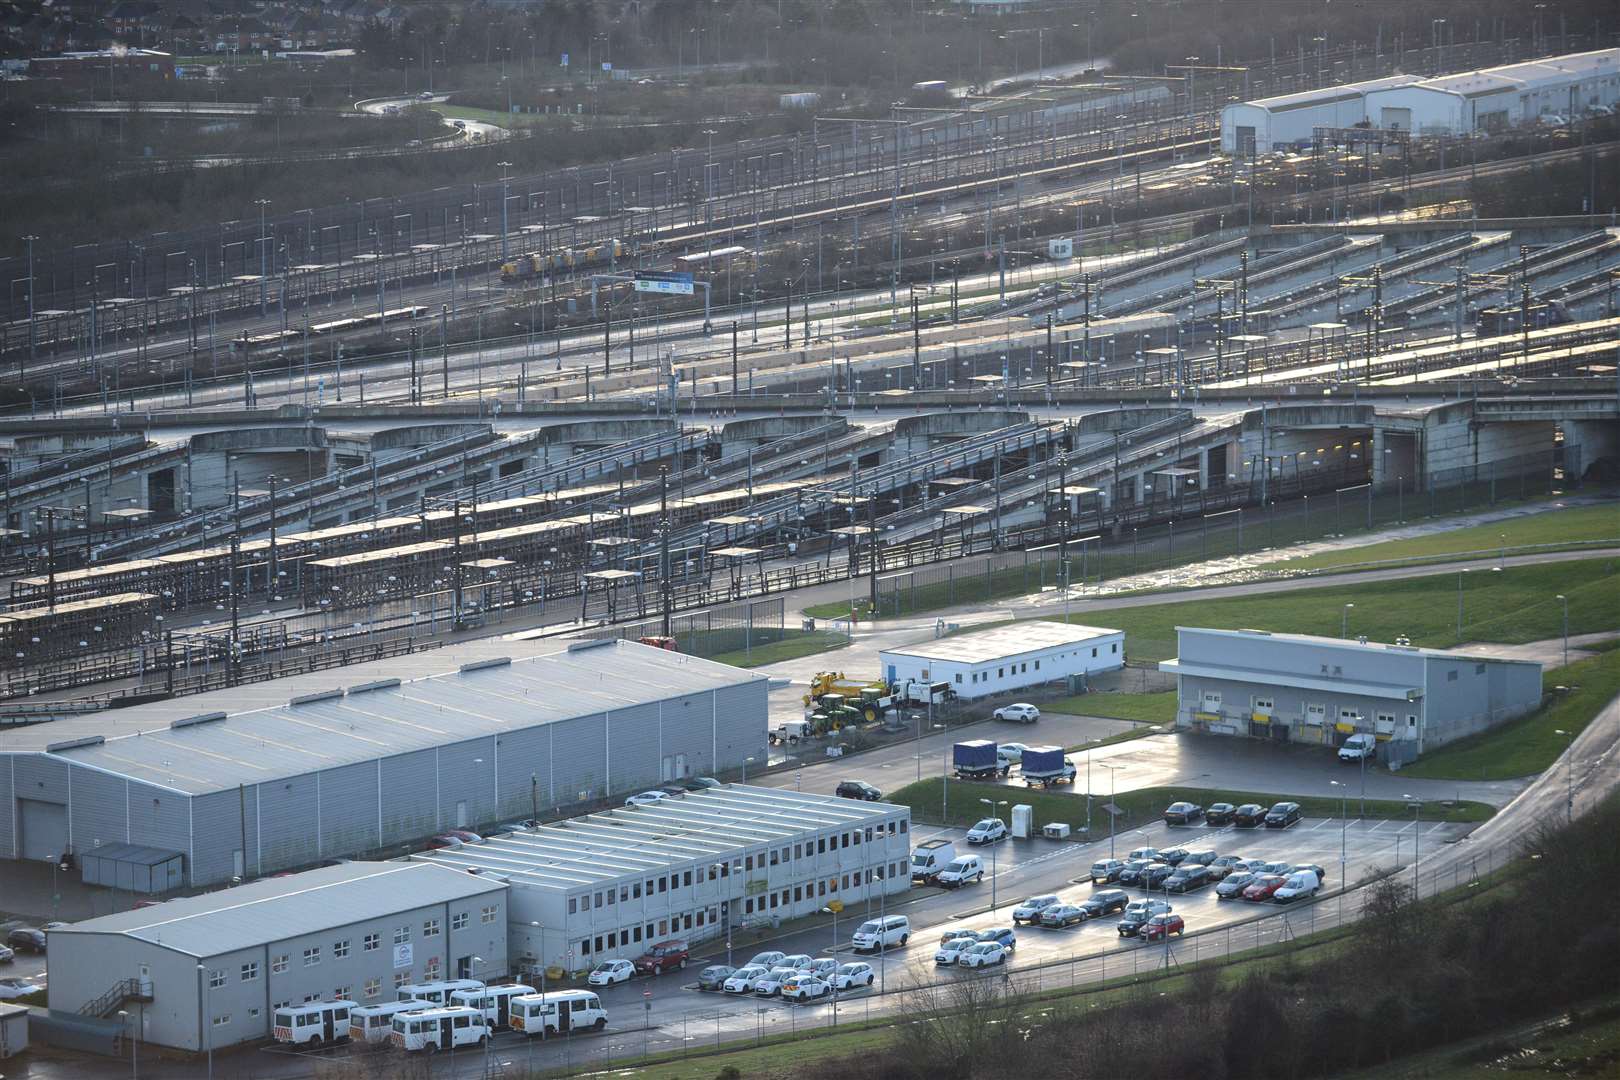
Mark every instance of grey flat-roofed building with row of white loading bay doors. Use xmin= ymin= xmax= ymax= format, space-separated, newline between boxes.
xmin=1158 ymin=627 xmax=1541 ymax=764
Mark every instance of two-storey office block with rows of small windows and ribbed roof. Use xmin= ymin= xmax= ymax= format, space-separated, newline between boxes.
xmin=415 ymin=784 xmax=910 ymax=973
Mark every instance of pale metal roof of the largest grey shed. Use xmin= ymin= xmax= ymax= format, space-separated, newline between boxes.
xmin=0 ymin=640 xmax=765 ymax=795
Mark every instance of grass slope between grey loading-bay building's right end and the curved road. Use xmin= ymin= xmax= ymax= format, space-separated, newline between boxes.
xmin=1401 ymin=649 xmax=1620 ymax=780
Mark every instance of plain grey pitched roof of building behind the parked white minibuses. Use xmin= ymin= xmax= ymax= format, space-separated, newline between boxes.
xmin=50 ymin=863 xmax=504 ymax=959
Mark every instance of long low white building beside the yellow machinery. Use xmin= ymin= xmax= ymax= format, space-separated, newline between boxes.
xmin=878 ymin=619 xmax=1124 ymax=698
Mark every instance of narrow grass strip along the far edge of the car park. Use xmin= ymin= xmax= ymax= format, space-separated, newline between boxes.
xmin=885 ymin=777 xmax=1495 ymax=839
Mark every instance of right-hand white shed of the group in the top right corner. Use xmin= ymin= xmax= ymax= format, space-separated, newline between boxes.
xmin=1367 ymin=49 xmax=1620 ymax=134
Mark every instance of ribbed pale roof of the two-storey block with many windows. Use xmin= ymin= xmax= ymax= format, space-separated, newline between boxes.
xmin=411 ymin=784 xmax=909 ymax=889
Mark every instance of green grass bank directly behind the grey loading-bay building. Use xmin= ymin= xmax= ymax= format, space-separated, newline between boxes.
xmin=1049 ymin=559 xmax=1620 ymax=661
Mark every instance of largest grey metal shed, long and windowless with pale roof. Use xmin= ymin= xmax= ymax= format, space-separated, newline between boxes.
xmin=0 ymin=641 xmax=766 ymax=886
